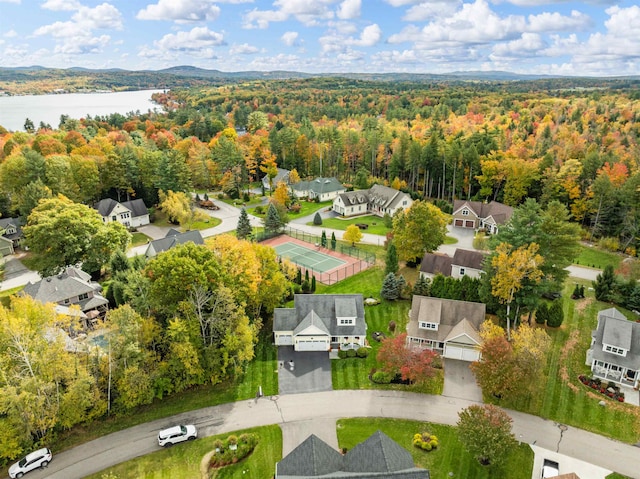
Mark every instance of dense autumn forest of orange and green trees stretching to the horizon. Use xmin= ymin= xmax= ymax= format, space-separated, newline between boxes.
xmin=0 ymin=77 xmax=640 ymax=253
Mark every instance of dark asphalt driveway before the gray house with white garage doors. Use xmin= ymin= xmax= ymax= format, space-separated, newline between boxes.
xmin=278 ymin=346 xmax=333 ymax=395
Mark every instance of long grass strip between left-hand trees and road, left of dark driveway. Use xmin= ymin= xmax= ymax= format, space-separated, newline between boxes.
xmin=54 ymin=335 xmax=278 ymax=452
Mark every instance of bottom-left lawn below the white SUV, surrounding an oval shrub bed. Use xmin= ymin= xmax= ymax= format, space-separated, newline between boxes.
xmin=87 ymin=425 xmax=282 ymax=479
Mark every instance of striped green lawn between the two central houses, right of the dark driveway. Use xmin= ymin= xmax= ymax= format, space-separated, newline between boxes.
xmin=317 ymin=267 xmax=444 ymax=394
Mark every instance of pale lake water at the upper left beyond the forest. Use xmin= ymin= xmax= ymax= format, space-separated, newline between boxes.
xmin=0 ymin=90 xmax=163 ymax=131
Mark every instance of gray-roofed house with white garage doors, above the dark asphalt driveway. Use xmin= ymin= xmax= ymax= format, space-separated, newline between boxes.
xmin=273 ymin=294 xmax=367 ymax=351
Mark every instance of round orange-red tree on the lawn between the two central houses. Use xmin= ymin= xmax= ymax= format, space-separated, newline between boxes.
xmin=376 ymin=333 xmax=437 ymax=383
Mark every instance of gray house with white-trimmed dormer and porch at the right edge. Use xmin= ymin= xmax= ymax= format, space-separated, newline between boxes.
xmin=586 ymin=308 xmax=640 ymax=387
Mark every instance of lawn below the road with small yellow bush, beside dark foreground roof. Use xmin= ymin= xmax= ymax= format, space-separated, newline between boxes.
xmin=337 ymin=418 xmax=533 ymax=479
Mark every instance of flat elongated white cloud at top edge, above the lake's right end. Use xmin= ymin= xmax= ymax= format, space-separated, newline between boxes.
xmin=136 ymin=0 xmax=220 ymax=23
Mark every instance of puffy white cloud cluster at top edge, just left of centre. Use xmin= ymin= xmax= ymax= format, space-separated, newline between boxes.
xmin=243 ymin=0 xmax=337 ymax=29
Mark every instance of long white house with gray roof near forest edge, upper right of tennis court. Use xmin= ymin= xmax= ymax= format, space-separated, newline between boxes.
xmin=332 ymin=185 xmax=413 ymax=218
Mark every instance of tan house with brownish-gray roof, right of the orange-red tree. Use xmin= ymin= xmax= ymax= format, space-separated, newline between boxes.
xmin=407 ymin=295 xmax=486 ymax=361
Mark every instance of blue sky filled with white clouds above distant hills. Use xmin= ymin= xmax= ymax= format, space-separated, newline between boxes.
xmin=0 ymin=0 xmax=640 ymax=76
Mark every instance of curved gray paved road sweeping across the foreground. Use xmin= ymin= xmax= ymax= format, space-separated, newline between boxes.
xmin=22 ymin=390 xmax=640 ymax=479
